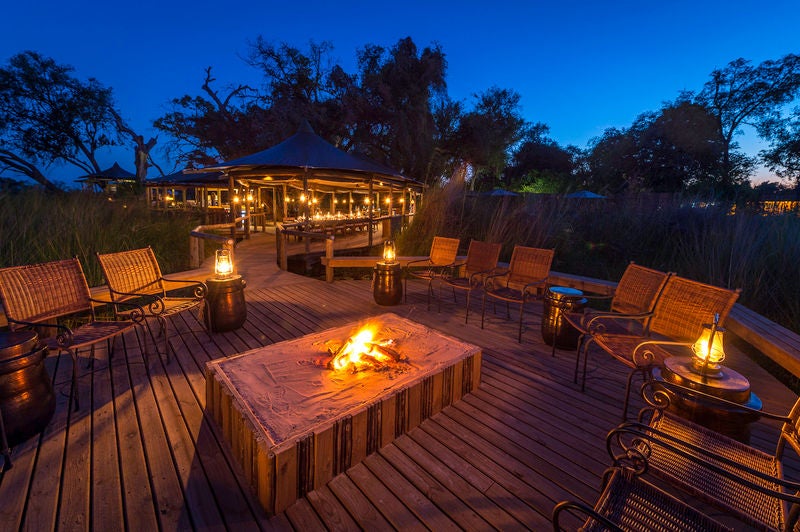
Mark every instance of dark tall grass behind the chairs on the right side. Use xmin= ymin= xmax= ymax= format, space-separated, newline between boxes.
xmin=398 ymin=190 xmax=800 ymax=332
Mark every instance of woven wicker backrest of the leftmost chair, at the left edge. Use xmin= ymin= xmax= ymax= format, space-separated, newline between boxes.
xmin=0 ymin=258 xmax=94 ymax=330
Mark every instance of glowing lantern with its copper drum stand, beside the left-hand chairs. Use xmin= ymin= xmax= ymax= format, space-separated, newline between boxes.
xmin=205 ymin=243 xmax=247 ymax=332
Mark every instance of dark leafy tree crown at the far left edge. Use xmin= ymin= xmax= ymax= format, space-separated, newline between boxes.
xmin=0 ymin=51 xmax=119 ymax=190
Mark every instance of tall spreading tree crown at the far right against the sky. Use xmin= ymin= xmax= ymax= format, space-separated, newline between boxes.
xmin=696 ymin=54 xmax=800 ymax=192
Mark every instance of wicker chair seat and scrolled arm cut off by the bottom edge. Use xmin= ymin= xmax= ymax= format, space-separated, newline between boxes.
xmin=552 ymin=467 xmax=731 ymax=532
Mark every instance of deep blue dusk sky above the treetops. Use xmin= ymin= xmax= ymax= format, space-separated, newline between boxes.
xmin=0 ymin=0 xmax=800 ymax=185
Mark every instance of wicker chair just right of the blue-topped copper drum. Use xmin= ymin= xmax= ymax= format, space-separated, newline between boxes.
xmin=553 ymin=262 xmax=671 ymax=391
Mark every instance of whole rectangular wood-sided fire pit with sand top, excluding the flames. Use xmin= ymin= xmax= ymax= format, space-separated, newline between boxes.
xmin=206 ymin=314 xmax=481 ymax=514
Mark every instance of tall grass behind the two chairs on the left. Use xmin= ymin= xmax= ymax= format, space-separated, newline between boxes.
xmin=0 ymin=190 xmax=199 ymax=286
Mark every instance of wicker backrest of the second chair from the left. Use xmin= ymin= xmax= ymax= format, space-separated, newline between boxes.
xmin=97 ymin=246 xmax=166 ymax=301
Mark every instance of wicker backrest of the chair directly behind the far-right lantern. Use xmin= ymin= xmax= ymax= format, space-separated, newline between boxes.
xmin=650 ymin=275 xmax=740 ymax=342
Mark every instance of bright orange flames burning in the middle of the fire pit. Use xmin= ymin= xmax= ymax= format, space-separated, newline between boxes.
xmin=327 ymin=326 xmax=408 ymax=373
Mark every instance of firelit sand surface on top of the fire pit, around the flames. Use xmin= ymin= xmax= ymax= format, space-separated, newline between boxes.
xmin=209 ymin=314 xmax=479 ymax=445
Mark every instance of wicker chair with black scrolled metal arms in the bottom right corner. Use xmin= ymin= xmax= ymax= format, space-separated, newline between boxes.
xmin=607 ymin=382 xmax=800 ymax=530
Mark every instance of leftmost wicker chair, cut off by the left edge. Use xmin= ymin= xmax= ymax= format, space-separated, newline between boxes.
xmin=0 ymin=258 xmax=144 ymax=410
